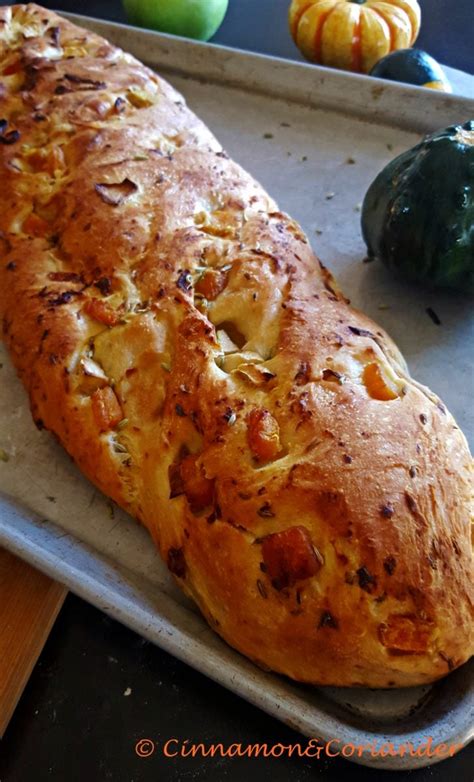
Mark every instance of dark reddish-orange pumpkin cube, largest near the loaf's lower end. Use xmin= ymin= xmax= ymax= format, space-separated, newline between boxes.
xmin=262 ymin=527 xmax=321 ymax=589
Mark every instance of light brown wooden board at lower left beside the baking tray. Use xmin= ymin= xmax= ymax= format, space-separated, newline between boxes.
xmin=0 ymin=548 xmax=67 ymax=738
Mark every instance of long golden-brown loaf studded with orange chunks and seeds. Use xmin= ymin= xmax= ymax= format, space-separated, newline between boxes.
xmin=0 ymin=5 xmax=474 ymax=687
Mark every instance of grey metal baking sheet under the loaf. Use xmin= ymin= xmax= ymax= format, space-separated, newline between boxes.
xmin=0 ymin=12 xmax=474 ymax=769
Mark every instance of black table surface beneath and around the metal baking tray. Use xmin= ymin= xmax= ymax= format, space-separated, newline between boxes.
xmin=0 ymin=0 xmax=474 ymax=782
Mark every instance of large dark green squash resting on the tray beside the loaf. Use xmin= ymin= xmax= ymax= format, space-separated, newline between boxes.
xmin=362 ymin=121 xmax=474 ymax=292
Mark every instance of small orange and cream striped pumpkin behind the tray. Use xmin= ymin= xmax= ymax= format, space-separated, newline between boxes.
xmin=289 ymin=0 xmax=421 ymax=73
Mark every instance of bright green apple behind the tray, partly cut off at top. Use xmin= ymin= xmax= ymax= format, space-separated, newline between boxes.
xmin=123 ymin=0 xmax=229 ymax=41
